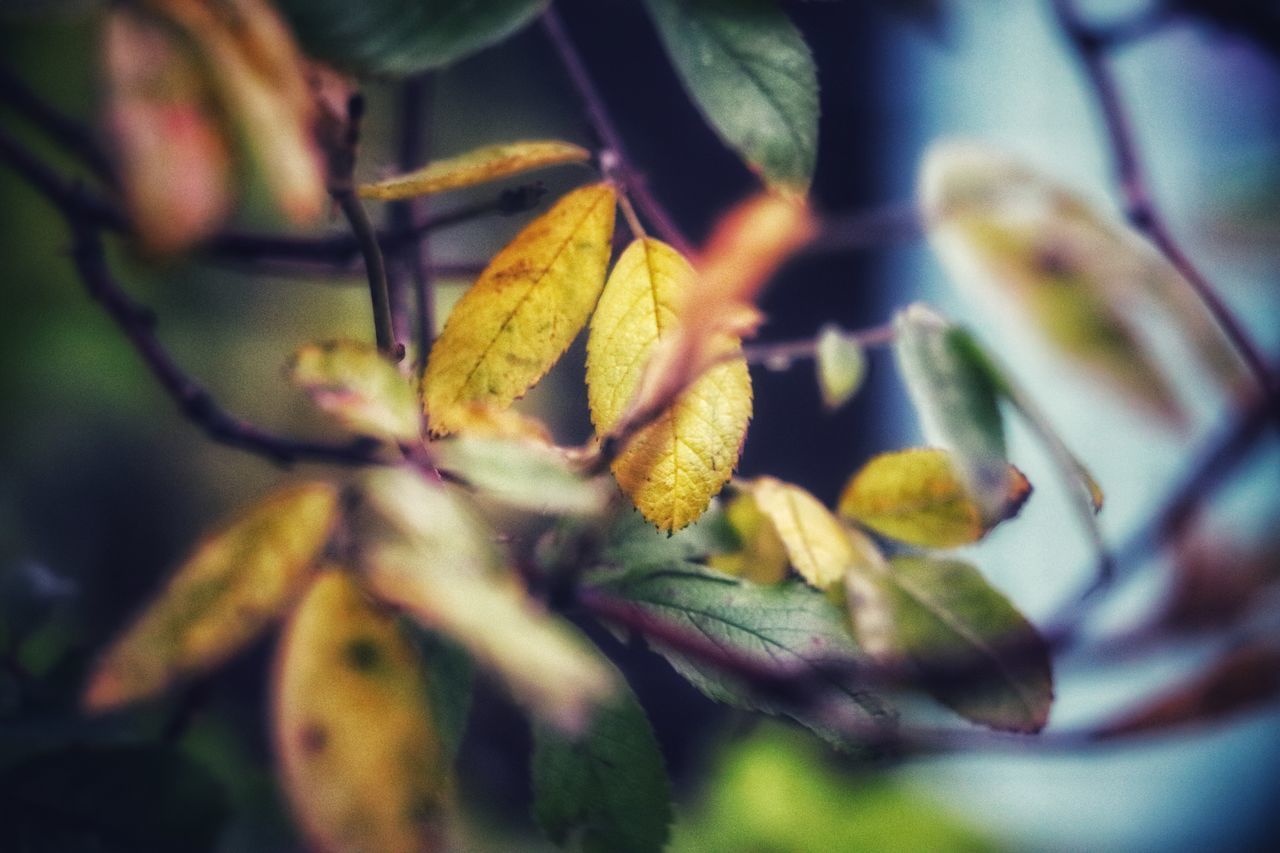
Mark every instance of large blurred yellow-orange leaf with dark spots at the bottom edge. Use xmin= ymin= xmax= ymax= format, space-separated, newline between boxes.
xmin=274 ymin=570 xmax=452 ymax=853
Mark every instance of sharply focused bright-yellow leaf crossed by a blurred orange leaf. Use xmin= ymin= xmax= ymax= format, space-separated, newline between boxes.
xmin=586 ymin=240 xmax=751 ymax=530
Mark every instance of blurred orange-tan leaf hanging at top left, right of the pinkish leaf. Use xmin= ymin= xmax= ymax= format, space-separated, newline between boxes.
xmin=158 ymin=0 xmax=329 ymax=222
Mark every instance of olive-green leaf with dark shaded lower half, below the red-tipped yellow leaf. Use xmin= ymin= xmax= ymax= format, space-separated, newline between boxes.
xmin=846 ymin=557 xmax=1053 ymax=733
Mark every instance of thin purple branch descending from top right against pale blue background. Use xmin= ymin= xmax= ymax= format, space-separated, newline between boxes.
xmin=1053 ymin=0 xmax=1272 ymax=393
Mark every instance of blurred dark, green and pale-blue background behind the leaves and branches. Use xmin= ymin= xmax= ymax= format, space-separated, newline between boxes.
xmin=0 ymin=0 xmax=1280 ymax=850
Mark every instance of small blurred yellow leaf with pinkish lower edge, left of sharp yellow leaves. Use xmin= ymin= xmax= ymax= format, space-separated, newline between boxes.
xmin=289 ymin=341 xmax=421 ymax=442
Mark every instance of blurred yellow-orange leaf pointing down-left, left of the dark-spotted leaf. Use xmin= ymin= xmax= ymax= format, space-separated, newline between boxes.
xmin=84 ymin=483 xmax=338 ymax=711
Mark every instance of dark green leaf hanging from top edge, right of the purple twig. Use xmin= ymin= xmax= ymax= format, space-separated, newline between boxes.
xmin=648 ymin=0 xmax=818 ymax=193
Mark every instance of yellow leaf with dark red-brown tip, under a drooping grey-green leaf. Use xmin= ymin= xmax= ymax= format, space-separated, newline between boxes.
xmin=840 ymin=448 xmax=1032 ymax=548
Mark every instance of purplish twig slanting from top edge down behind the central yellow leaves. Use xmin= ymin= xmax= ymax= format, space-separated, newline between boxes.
xmin=543 ymin=5 xmax=692 ymax=257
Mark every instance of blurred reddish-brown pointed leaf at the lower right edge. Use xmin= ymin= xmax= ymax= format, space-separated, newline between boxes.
xmin=1097 ymin=644 xmax=1280 ymax=738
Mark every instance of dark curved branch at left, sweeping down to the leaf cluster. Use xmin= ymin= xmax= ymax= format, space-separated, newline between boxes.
xmin=70 ymin=218 xmax=379 ymax=465
